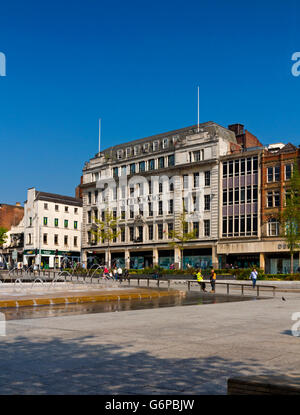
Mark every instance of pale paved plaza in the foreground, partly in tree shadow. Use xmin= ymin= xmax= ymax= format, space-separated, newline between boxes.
xmin=0 ymin=287 xmax=300 ymax=394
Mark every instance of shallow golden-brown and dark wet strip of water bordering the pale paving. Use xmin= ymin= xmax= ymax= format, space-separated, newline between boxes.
xmin=1 ymin=292 xmax=259 ymax=320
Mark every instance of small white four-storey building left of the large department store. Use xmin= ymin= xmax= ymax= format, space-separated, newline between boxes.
xmin=24 ymin=188 xmax=82 ymax=268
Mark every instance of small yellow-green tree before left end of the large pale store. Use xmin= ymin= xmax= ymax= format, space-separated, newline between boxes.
xmin=91 ymin=209 xmax=121 ymax=267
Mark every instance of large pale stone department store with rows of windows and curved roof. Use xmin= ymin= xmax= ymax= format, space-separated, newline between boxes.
xmin=81 ymin=122 xmax=237 ymax=268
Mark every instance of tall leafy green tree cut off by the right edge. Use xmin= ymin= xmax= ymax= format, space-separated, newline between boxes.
xmin=281 ymin=161 xmax=300 ymax=274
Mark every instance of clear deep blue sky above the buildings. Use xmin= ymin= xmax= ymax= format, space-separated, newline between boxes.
xmin=0 ymin=0 xmax=300 ymax=203
